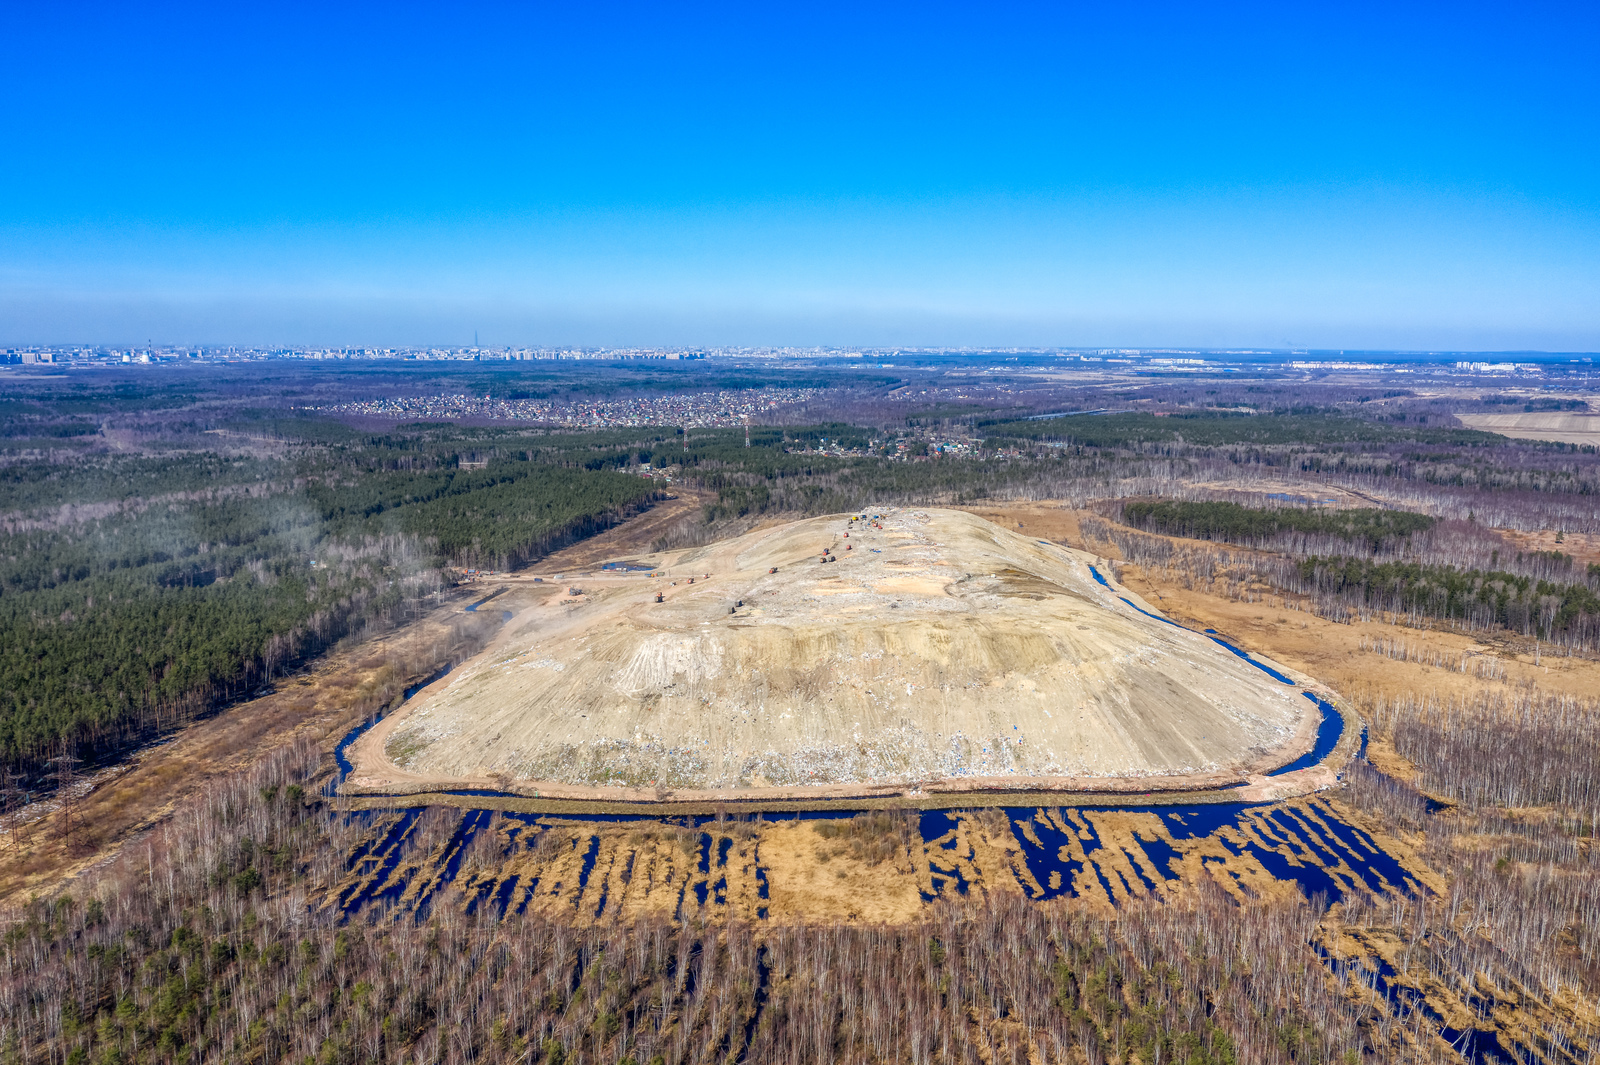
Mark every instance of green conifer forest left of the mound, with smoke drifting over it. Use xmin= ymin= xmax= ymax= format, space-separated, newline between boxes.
xmin=0 ymin=438 xmax=658 ymax=772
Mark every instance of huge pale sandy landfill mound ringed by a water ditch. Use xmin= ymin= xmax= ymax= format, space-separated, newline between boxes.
xmin=344 ymin=509 xmax=1318 ymax=801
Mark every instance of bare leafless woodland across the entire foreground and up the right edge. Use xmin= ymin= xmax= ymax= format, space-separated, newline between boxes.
xmin=0 ymin=674 xmax=1600 ymax=1065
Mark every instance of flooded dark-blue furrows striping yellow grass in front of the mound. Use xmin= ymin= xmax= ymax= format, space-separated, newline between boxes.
xmin=334 ymin=786 xmax=1426 ymax=919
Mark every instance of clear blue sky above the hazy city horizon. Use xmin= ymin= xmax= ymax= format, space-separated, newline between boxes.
xmin=0 ymin=0 xmax=1600 ymax=350
